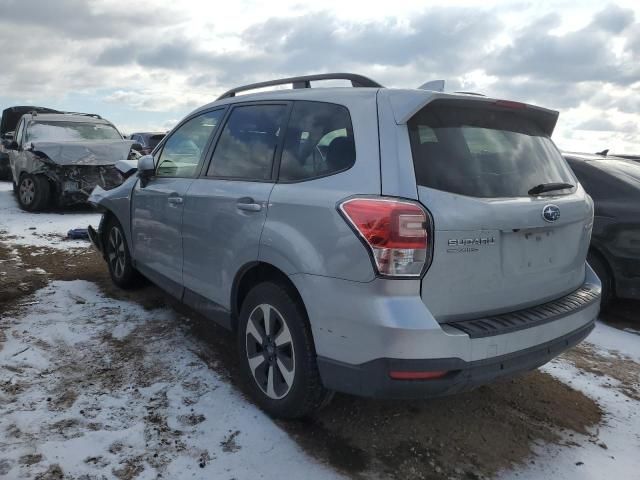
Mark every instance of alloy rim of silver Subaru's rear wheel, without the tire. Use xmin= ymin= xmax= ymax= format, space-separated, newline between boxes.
xmin=245 ymin=303 xmax=296 ymax=400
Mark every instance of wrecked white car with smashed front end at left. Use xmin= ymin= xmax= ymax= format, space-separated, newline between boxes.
xmin=7 ymin=112 xmax=140 ymax=211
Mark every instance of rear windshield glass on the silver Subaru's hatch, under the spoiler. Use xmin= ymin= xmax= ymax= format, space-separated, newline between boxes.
xmin=408 ymin=103 xmax=576 ymax=198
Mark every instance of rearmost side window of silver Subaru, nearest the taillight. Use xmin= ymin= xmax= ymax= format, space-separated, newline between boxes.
xmin=279 ymin=102 xmax=356 ymax=181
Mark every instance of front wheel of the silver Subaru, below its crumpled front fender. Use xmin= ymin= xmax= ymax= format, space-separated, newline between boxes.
xmin=103 ymin=217 xmax=140 ymax=290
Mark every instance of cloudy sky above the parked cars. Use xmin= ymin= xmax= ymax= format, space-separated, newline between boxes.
xmin=0 ymin=0 xmax=640 ymax=153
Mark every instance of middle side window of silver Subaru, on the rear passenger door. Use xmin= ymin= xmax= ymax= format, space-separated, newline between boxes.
xmin=207 ymin=105 xmax=288 ymax=180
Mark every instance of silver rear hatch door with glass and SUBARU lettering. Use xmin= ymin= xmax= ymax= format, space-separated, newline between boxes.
xmin=408 ymin=100 xmax=593 ymax=322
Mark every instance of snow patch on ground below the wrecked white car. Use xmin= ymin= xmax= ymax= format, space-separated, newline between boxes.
xmin=0 ymin=182 xmax=100 ymax=249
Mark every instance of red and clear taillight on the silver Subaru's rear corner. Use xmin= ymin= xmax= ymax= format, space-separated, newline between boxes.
xmin=340 ymin=198 xmax=431 ymax=277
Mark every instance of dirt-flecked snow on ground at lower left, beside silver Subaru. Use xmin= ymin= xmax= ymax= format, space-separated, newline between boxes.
xmin=0 ymin=280 xmax=338 ymax=479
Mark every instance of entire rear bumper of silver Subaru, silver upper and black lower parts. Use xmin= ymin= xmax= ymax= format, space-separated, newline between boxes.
xmin=290 ymin=265 xmax=601 ymax=398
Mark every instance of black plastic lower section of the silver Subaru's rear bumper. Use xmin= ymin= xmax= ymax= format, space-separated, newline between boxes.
xmin=318 ymin=319 xmax=595 ymax=399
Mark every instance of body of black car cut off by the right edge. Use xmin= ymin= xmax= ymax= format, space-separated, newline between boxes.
xmin=564 ymin=153 xmax=640 ymax=299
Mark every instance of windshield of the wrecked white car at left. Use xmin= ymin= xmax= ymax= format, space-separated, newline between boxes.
xmin=26 ymin=122 xmax=122 ymax=142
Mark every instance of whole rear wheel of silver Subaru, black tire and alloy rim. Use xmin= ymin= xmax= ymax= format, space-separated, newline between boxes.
xmin=238 ymin=282 xmax=333 ymax=418
